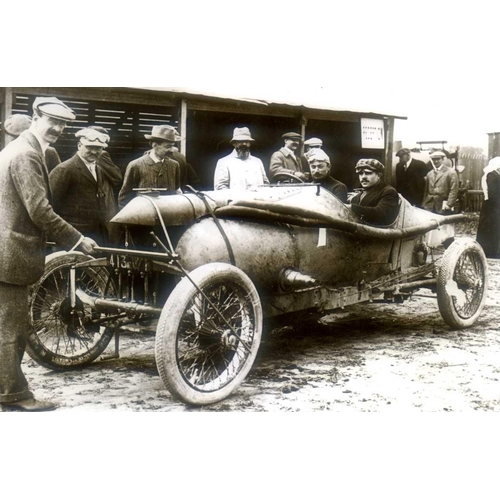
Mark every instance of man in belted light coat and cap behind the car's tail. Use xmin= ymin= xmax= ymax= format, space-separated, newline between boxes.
xmin=422 ymin=151 xmax=458 ymax=214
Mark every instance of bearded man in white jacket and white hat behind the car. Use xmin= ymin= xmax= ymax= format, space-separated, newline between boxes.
xmin=214 ymin=127 xmax=269 ymax=190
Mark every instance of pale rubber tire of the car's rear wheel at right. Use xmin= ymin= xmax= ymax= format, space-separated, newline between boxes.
xmin=437 ymin=238 xmax=488 ymax=329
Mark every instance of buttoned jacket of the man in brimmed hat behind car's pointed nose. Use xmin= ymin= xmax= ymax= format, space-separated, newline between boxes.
xmin=118 ymin=154 xmax=181 ymax=208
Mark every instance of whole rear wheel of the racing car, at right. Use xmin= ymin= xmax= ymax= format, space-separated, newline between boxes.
xmin=437 ymin=238 xmax=488 ymax=328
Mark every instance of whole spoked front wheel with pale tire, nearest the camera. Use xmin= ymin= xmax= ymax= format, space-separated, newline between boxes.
xmin=156 ymin=263 xmax=262 ymax=405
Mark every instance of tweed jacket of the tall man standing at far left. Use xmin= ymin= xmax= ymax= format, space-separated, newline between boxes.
xmin=0 ymin=130 xmax=81 ymax=285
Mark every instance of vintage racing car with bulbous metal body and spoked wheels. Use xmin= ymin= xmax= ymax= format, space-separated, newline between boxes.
xmin=27 ymin=184 xmax=488 ymax=404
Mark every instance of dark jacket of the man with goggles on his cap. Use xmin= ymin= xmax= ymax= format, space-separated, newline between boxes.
xmin=49 ymin=154 xmax=122 ymax=245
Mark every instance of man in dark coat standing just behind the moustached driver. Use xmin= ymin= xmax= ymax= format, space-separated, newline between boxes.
xmin=396 ymin=148 xmax=431 ymax=207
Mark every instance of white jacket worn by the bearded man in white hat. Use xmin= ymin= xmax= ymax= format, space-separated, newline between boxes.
xmin=214 ymin=149 xmax=269 ymax=190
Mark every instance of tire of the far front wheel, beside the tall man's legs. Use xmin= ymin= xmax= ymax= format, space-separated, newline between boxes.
xmin=26 ymin=252 xmax=114 ymax=371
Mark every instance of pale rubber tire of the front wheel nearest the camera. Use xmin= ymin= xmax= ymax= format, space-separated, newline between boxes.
xmin=155 ymin=262 xmax=263 ymax=405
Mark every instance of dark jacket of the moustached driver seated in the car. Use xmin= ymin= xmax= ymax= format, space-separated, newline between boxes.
xmin=351 ymin=181 xmax=399 ymax=226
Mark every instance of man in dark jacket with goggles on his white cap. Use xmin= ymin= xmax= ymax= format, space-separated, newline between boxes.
xmin=50 ymin=128 xmax=122 ymax=246
